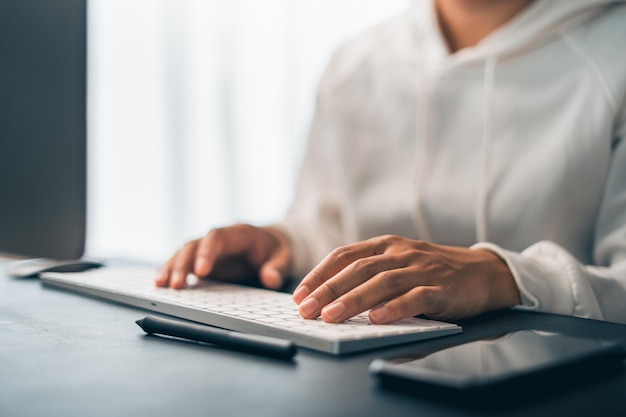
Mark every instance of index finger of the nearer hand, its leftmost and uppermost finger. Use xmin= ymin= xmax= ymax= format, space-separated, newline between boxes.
xmin=293 ymin=239 xmax=383 ymax=304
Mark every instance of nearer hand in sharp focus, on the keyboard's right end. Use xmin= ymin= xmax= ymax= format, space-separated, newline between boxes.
xmin=293 ymin=236 xmax=521 ymax=323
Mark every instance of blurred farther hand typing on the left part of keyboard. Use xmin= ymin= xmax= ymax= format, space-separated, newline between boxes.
xmin=155 ymin=224 xmax=292 ymax=289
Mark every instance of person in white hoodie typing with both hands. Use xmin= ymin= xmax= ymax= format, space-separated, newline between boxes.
xmin=156 ymin=0 xmax=626 ymax=323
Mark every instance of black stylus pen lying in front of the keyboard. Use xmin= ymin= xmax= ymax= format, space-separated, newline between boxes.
xmin=135 ymin=315 xmax=296 ymax=359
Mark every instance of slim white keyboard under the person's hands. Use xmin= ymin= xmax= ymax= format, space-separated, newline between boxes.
xmin=41 ymin=267 xmax=461 ymax=354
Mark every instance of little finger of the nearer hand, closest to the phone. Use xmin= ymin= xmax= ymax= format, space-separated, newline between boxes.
xmin=369 ymin=286 xmax=451 ymax=324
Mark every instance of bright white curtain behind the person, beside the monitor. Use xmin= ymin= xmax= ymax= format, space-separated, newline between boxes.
xmin=87 ymin=0 xmax=407 ymax=262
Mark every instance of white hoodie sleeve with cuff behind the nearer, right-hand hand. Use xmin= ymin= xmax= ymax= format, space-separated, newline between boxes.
xmin=473 ymin=118 xmax=626 ymax=323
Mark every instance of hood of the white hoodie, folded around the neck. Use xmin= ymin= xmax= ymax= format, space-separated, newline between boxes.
xmin=411 ymin=0 xmax=626 ymax=64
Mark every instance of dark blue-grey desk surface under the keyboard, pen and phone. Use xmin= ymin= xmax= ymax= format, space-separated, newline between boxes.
xmin=0 ymin=263 xmax=626 ymax=417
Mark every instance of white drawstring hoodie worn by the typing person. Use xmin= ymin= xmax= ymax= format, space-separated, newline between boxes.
xmin=281 ymin=0 xmax=626 ymax=323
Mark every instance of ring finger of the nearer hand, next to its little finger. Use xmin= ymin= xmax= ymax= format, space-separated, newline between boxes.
xmin=320 ymin=268 xmax=415 ymax=323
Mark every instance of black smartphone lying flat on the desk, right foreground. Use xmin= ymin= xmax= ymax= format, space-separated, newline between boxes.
xmin=370 ymin=330 xmax=626 ymax=409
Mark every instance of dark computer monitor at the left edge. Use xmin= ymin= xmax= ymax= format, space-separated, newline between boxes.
xmin=0 ymin=0 xmax=87 ymax=260
